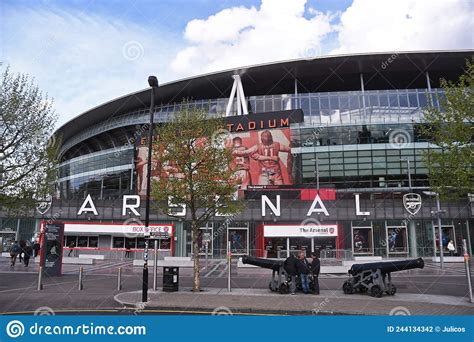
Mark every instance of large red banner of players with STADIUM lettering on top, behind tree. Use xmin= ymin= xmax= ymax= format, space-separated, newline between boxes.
xmin=136 ymin=109 xmax=303 ymax=195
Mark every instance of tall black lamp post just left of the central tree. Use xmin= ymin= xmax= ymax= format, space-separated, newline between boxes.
xmin=142 ymin=76 xmax=158 ymax=302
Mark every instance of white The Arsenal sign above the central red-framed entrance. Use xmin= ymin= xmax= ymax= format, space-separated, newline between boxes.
xmin=263 ymin=224 xmax=337 ymax=238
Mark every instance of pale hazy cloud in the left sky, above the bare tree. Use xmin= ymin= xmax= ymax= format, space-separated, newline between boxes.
xmin=2 ymin=7 xmax=179 ymax=125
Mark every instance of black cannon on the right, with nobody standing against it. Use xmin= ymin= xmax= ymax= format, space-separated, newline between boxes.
xmin=342 ymin=258 xmax=425 ymax=297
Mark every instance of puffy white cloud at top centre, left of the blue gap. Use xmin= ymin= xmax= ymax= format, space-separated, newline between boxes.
xmin=171 ymin=0 xmax=333 ymax=75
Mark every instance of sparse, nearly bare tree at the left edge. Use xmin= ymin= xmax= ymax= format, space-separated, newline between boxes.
xmin=0 ymin=68 xmax=60 ymax=212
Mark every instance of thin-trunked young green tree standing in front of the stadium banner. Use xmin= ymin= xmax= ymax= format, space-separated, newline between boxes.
xmin=152 ymin=107 xmax=242 ymax=291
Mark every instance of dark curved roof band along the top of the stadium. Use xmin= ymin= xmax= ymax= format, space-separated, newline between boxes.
xmin=57 ymin=50 xmax=474 ymax=141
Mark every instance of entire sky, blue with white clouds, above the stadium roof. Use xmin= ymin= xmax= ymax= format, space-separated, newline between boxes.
xmin=0 ymin=0 xmax=474 ymax=125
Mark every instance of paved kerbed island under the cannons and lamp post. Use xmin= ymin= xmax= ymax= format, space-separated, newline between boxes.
xmin=114 ymin=288 xmax=474 ymax=315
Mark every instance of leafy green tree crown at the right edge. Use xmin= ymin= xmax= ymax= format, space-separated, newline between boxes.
xmin=421 ymin=58 xmax=474 ymax=198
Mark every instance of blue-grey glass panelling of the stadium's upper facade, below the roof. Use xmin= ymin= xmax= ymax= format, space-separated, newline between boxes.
xmin=59 ymin=89 xmax=442 ymax=199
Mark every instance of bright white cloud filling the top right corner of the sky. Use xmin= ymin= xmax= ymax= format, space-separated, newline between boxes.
xmin=331 ymin=0 xmax=474 ymax=54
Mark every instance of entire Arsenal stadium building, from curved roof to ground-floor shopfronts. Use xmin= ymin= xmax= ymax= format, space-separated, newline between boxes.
xmin=2 ymin=51 xmax=474 ymax=259
